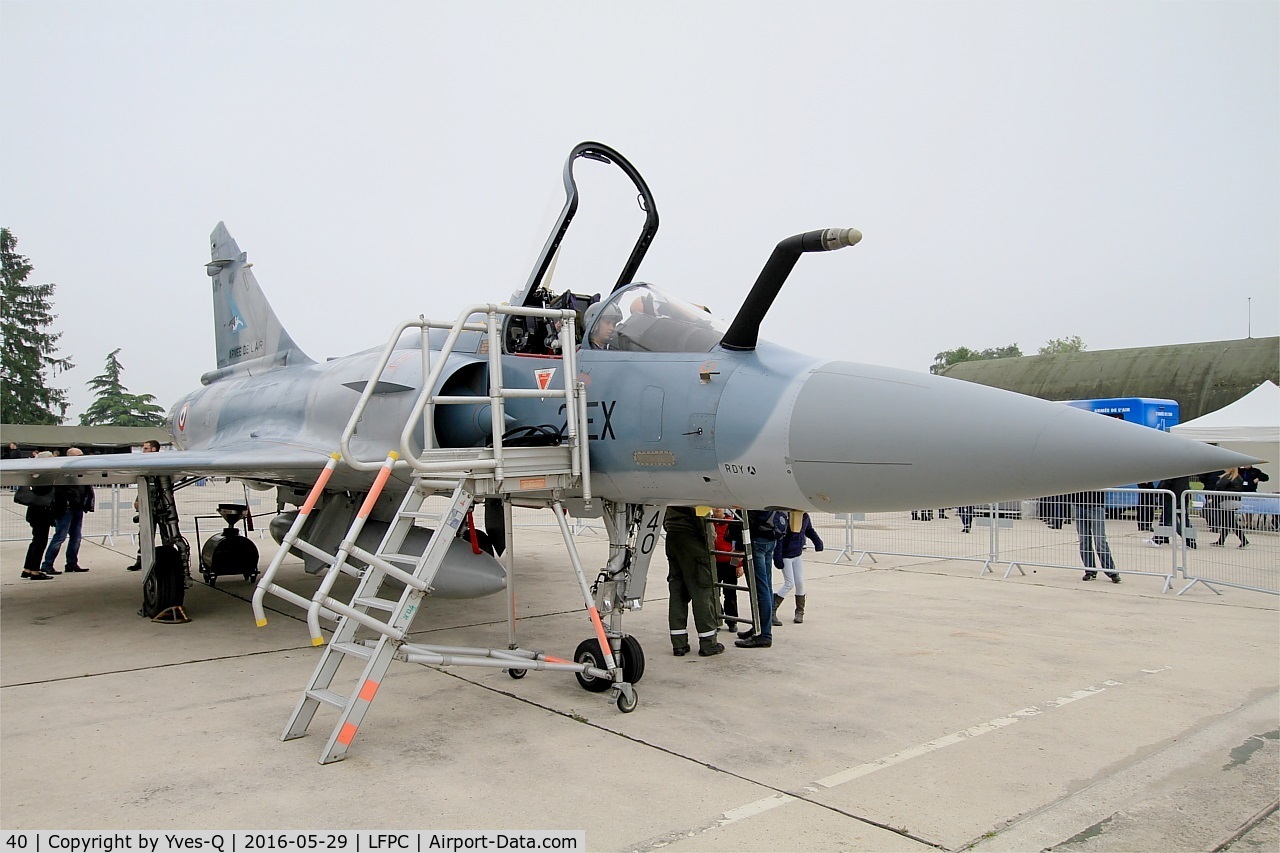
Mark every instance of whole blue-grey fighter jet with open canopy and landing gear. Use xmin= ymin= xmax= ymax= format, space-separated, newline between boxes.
xmin=0 ymin=142 xmax=1247 ymax=753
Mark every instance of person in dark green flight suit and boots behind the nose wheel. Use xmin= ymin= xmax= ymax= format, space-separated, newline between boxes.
xmin=662 ymin=506 xmax=724 ymax=657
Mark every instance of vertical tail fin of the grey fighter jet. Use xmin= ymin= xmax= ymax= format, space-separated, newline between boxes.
xmin=205 ymin=223 xmax=314 ymax=373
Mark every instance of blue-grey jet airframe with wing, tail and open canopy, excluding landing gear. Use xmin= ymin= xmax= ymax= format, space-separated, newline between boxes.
xmin=0 ymin=142 xmax=1252 ymax=597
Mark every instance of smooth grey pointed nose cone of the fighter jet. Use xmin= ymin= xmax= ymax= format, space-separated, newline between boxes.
xmin=788 ymin=362 xmax=1249 ymax=511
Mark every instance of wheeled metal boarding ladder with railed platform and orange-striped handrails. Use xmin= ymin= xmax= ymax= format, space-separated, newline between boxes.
xmin=253 ymin=305 xmax=619 ymax=763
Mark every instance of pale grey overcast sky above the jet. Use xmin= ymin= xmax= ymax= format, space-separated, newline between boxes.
xmin=0 ymin=0 xmax=1280 ymax=419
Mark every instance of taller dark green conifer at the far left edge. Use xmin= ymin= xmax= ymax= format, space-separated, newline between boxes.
xmin=0 ymin=228 xmax=76 ymax=424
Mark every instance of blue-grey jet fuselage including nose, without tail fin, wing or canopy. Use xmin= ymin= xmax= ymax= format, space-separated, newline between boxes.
xmin=172 ymin=284 xmax=1249 ymax=517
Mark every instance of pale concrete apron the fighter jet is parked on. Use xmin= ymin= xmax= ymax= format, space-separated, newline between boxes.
xmin=0 ymin=530 xmax=1280 ymax=850
